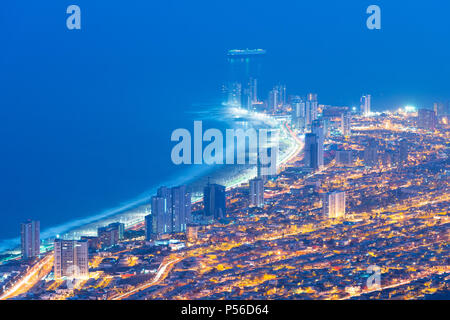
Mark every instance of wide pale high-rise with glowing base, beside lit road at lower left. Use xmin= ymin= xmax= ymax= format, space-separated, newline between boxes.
xmin=54 ymin=239 xmax=89 ymax=279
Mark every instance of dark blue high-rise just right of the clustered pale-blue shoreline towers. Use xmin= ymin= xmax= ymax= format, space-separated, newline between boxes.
xmin=203 ymin=182 xmax=226 ymax=221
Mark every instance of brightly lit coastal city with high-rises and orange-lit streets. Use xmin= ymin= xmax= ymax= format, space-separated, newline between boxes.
xmin=3 ymin=48 xmax=449 ymax=299
